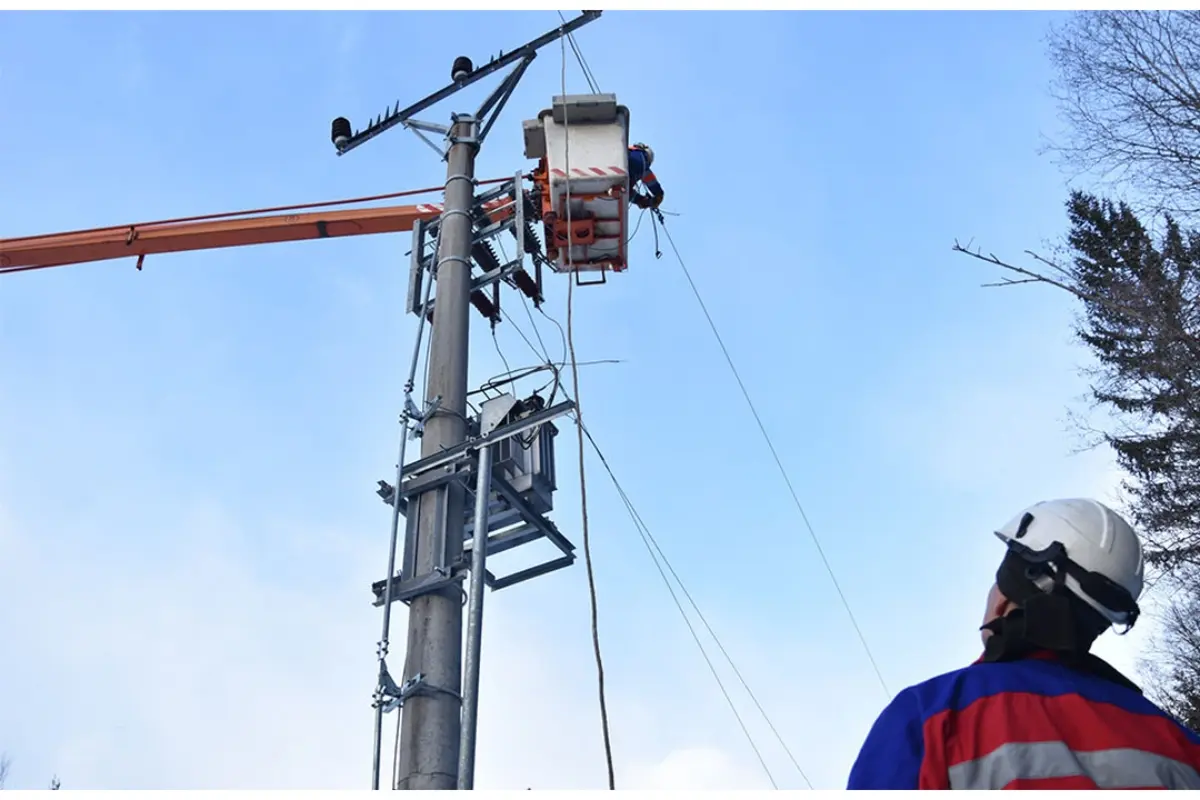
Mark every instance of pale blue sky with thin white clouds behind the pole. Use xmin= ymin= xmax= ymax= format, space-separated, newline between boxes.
xmin=0 ymin=11 xmax=1161 ymax=788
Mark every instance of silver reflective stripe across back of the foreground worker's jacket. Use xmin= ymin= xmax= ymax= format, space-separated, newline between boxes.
xmin=949 ymin=741 xmax=1200 ymax=789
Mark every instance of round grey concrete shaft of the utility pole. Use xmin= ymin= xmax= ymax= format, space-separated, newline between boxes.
xmin=395 ymin=115 xmax=479 ymax=789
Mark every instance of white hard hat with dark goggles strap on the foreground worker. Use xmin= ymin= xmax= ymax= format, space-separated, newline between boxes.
xmin=996 ymin=499 xmax=1145 ymax=626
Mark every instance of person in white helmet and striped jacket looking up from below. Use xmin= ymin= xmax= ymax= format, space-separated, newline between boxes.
xmin=848 ymin=500 xmax=1200 ymax=789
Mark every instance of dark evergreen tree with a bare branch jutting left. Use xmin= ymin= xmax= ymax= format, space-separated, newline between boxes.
xmin=953 ymin=192 xmax=1200 ymax=573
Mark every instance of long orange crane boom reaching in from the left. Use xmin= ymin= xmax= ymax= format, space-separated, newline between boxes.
xmin=0 ymin=192 xmax=512 ymax=273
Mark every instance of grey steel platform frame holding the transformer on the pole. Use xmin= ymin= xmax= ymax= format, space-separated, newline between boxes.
xmin=371 ymin=396 xmax=575 ymax=606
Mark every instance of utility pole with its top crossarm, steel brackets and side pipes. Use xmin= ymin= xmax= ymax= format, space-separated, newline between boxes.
xmin=331 ymin=11 xmax=601 ymax=789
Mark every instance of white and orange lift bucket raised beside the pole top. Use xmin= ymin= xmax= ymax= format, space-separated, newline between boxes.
xmin=524 ymin=95 xmax=630 ymax=272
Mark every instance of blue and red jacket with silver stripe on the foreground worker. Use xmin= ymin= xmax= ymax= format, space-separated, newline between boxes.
xmin=847 ymin=654 xmax=1200 ymax=789
